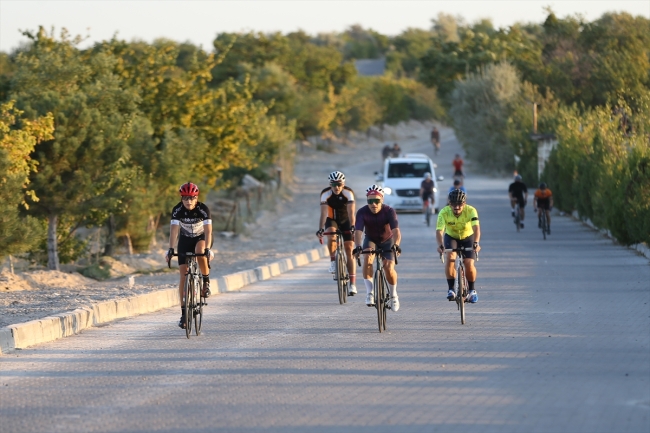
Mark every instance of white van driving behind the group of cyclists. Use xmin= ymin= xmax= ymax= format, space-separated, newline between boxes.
xmin=375 ymin=153 xmax=446 ymax=213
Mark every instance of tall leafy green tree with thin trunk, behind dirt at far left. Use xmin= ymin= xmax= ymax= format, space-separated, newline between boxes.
xmin=10 ymin=28 xmax=137 ymax=269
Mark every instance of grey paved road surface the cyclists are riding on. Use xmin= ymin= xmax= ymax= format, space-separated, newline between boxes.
xmin=0 ymin=133 xmax=650 ymax=433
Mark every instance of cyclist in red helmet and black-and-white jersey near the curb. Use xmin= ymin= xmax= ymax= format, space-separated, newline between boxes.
xmin=165 ymin=182 xmax=212 ymax=328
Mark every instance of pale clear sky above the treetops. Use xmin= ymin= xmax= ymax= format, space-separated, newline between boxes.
xmin=0 ymin=0 xmax=650 ymax=52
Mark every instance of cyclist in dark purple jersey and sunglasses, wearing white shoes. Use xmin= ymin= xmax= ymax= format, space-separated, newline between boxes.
xmin=354 ymin=185 xmax=402 ymax=311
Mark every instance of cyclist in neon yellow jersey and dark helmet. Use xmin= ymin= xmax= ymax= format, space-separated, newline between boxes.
xmin=436 ymin=190 xmax=481 ymax=303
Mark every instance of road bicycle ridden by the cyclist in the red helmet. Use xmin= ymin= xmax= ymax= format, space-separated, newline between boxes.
xmin=169 ymin=252 xmax=210 ymax=338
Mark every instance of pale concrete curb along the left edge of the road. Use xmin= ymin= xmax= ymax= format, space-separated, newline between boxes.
xmin=0 ymin=246 xmax=329 ymax=355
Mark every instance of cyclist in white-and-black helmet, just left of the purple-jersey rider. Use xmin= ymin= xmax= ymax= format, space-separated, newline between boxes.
xmin=316 ymin=171 xmax=357 ymax=296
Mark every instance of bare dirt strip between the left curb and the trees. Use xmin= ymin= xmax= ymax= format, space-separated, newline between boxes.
xmin=0 ymin=122 xmax=440 ymax=327
